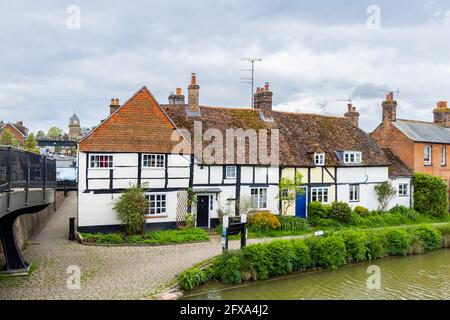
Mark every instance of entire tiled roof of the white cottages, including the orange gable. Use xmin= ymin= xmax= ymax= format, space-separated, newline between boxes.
xmin=80 ymin=87 xmax=389 ymax=166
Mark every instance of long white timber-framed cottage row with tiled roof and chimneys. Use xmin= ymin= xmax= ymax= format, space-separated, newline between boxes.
xmin=77 ymin=74 xmax=411 ymax=232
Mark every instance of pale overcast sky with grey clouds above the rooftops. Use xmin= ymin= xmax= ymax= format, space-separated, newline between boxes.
xmin=0 ymin=0 xmax=450 ymax=131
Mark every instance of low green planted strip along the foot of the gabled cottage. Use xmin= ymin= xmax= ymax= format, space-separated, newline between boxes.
xmin=81 ymin=228 xmax=209 ymax=245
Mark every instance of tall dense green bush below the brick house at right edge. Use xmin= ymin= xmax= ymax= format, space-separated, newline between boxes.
xmin=413 ymin=173 xmax=448 ymax=216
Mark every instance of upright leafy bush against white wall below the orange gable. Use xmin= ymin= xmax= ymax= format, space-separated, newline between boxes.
xmin=114 ymin=186 xmax=149 ymax=235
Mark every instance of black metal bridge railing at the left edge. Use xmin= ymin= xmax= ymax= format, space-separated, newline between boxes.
xmin=0 ymin=146 xmax=56 ymax=192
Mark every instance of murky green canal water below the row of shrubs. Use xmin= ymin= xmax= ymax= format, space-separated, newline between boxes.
xmin=185 ymin=249 xmax=450 ymax=300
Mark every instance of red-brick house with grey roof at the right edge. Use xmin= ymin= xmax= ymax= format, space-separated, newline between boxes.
xmin=371 ymin=92 xmax=450 ymax=183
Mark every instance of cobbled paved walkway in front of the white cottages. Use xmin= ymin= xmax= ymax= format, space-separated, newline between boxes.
xmin=0 ymin=193 xmax=294 ymax=299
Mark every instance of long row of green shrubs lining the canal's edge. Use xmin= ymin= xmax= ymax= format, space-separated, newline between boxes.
xmin=177 ymin=223 xmax=450 ymax=290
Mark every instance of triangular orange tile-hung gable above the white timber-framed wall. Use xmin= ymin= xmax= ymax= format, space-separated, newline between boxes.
xmin=79 ymin=87 xmax=183 ymax=153
